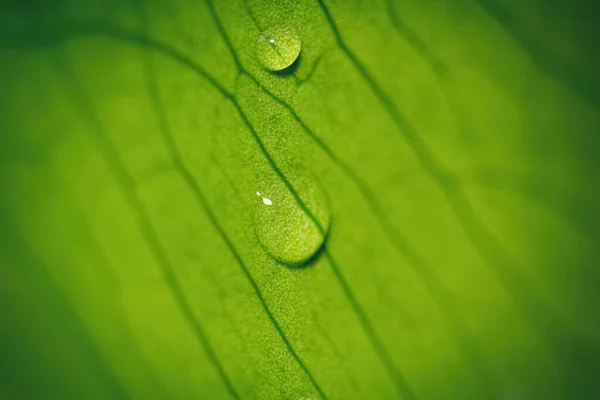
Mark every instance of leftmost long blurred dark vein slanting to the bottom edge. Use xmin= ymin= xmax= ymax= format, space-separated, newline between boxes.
xmin=53 ymin=49 xmax=240 ymax=400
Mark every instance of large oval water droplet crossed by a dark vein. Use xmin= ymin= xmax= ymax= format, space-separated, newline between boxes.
xmin=253 ymin=174 xmax=331 ymax=267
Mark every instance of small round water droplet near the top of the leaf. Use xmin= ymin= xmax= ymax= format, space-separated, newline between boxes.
xmin=256 ymin=27 xmax=302 ymax=71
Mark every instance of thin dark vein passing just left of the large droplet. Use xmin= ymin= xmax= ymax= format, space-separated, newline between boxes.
xmin=141 ymin=38 xmax=327 ymax=400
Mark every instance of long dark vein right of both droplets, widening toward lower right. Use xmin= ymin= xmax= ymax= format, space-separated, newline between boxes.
xmin=316 ymin=0 xmax=600 ymax=390
